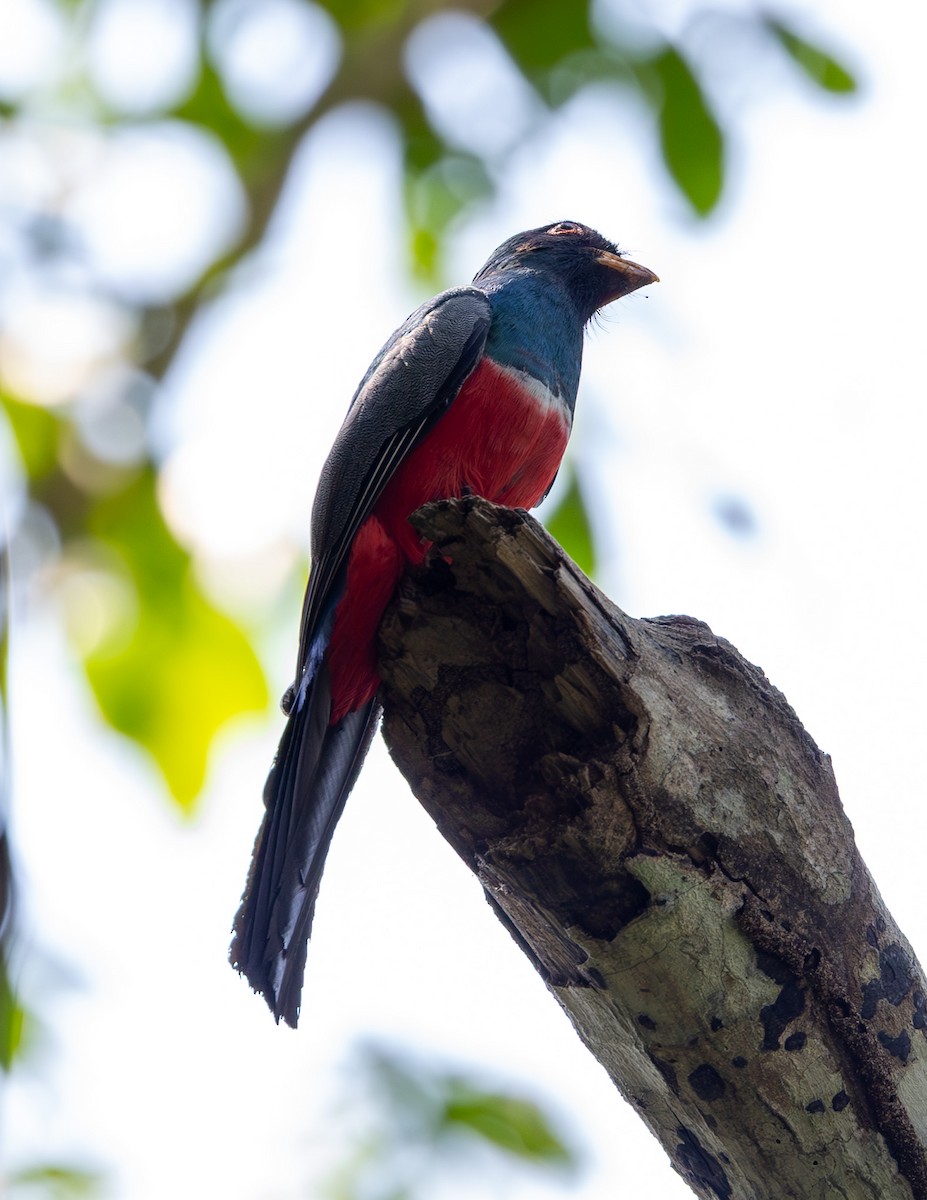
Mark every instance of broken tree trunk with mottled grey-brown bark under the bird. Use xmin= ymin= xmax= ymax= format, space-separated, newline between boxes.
xmin=381 ymin=499 xmax=927 ymax=1200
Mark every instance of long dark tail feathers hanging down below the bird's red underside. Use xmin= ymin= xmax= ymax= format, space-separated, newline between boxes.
xmin=228 ymin=665 xmax=379 ymax=1027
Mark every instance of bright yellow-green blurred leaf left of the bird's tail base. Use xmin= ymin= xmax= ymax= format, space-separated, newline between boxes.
xmin=84 ymin=468 xmax=268 ymax=811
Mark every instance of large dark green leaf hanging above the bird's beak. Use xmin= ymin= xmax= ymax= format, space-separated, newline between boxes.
xmin=646 ymin=46 xmax=724 ymax=217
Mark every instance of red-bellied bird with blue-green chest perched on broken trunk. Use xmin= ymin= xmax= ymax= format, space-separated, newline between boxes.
xmin=229 ymin=221 xmax=658 ymax=1027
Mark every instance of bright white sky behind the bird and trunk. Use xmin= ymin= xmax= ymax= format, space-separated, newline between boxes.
xmin=0 ymin=0 xmax=927 ymax=1200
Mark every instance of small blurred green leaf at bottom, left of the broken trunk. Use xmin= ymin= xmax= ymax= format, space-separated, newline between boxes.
xmin=443 ymin=1080 xmax=574 ymax=1165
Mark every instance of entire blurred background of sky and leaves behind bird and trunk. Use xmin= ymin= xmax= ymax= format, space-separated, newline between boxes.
xmin=0 ymin=0 xmax=927 ymax=1200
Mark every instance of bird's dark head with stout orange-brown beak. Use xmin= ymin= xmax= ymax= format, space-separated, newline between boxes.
xmin=473 ymin=221 xmax=659 ymax=320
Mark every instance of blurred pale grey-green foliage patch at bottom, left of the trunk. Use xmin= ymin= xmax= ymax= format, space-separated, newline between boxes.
xmin=323 ymin=1045 xmax=580 ymax=1200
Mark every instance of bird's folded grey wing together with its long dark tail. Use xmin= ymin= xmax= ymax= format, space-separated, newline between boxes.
xmin=231 ymin=288 xmax=491 ymax=1025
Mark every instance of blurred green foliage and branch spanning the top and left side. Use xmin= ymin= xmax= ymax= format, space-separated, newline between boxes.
xmin=0 ymin=0 xmax=855 ymax=810
